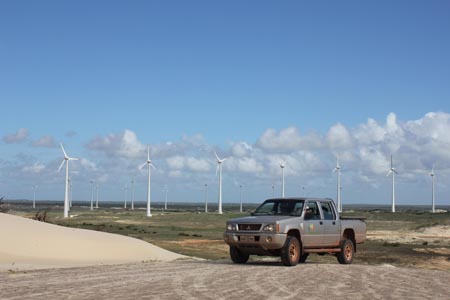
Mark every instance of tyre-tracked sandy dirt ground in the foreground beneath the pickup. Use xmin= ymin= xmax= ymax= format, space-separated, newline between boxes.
xmin=0 ymin=261 xmax=450 ymax=300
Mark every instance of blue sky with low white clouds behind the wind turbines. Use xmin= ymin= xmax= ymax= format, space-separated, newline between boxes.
xmin=0 ymin=0 xmax=450 ymax=205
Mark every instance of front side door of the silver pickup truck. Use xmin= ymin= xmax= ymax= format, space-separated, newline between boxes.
xmin=302 ymin=200 xmax=324 ymax=248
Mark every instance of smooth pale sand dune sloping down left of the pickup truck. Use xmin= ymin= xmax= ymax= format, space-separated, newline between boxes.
xmin=0 ymin=213 xmax=184 ymax=269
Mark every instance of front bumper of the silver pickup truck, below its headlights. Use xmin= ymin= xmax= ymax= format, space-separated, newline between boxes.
xmin=223 ymin=231 xmax=286 ymax=251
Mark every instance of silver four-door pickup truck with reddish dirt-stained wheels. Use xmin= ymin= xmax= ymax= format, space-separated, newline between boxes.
xmin=224 ymin=198 xmax=366 ymax=266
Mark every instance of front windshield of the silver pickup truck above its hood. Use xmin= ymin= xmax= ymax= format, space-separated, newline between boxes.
xmin=253 ymin=199 xmax=305 ymax=216
